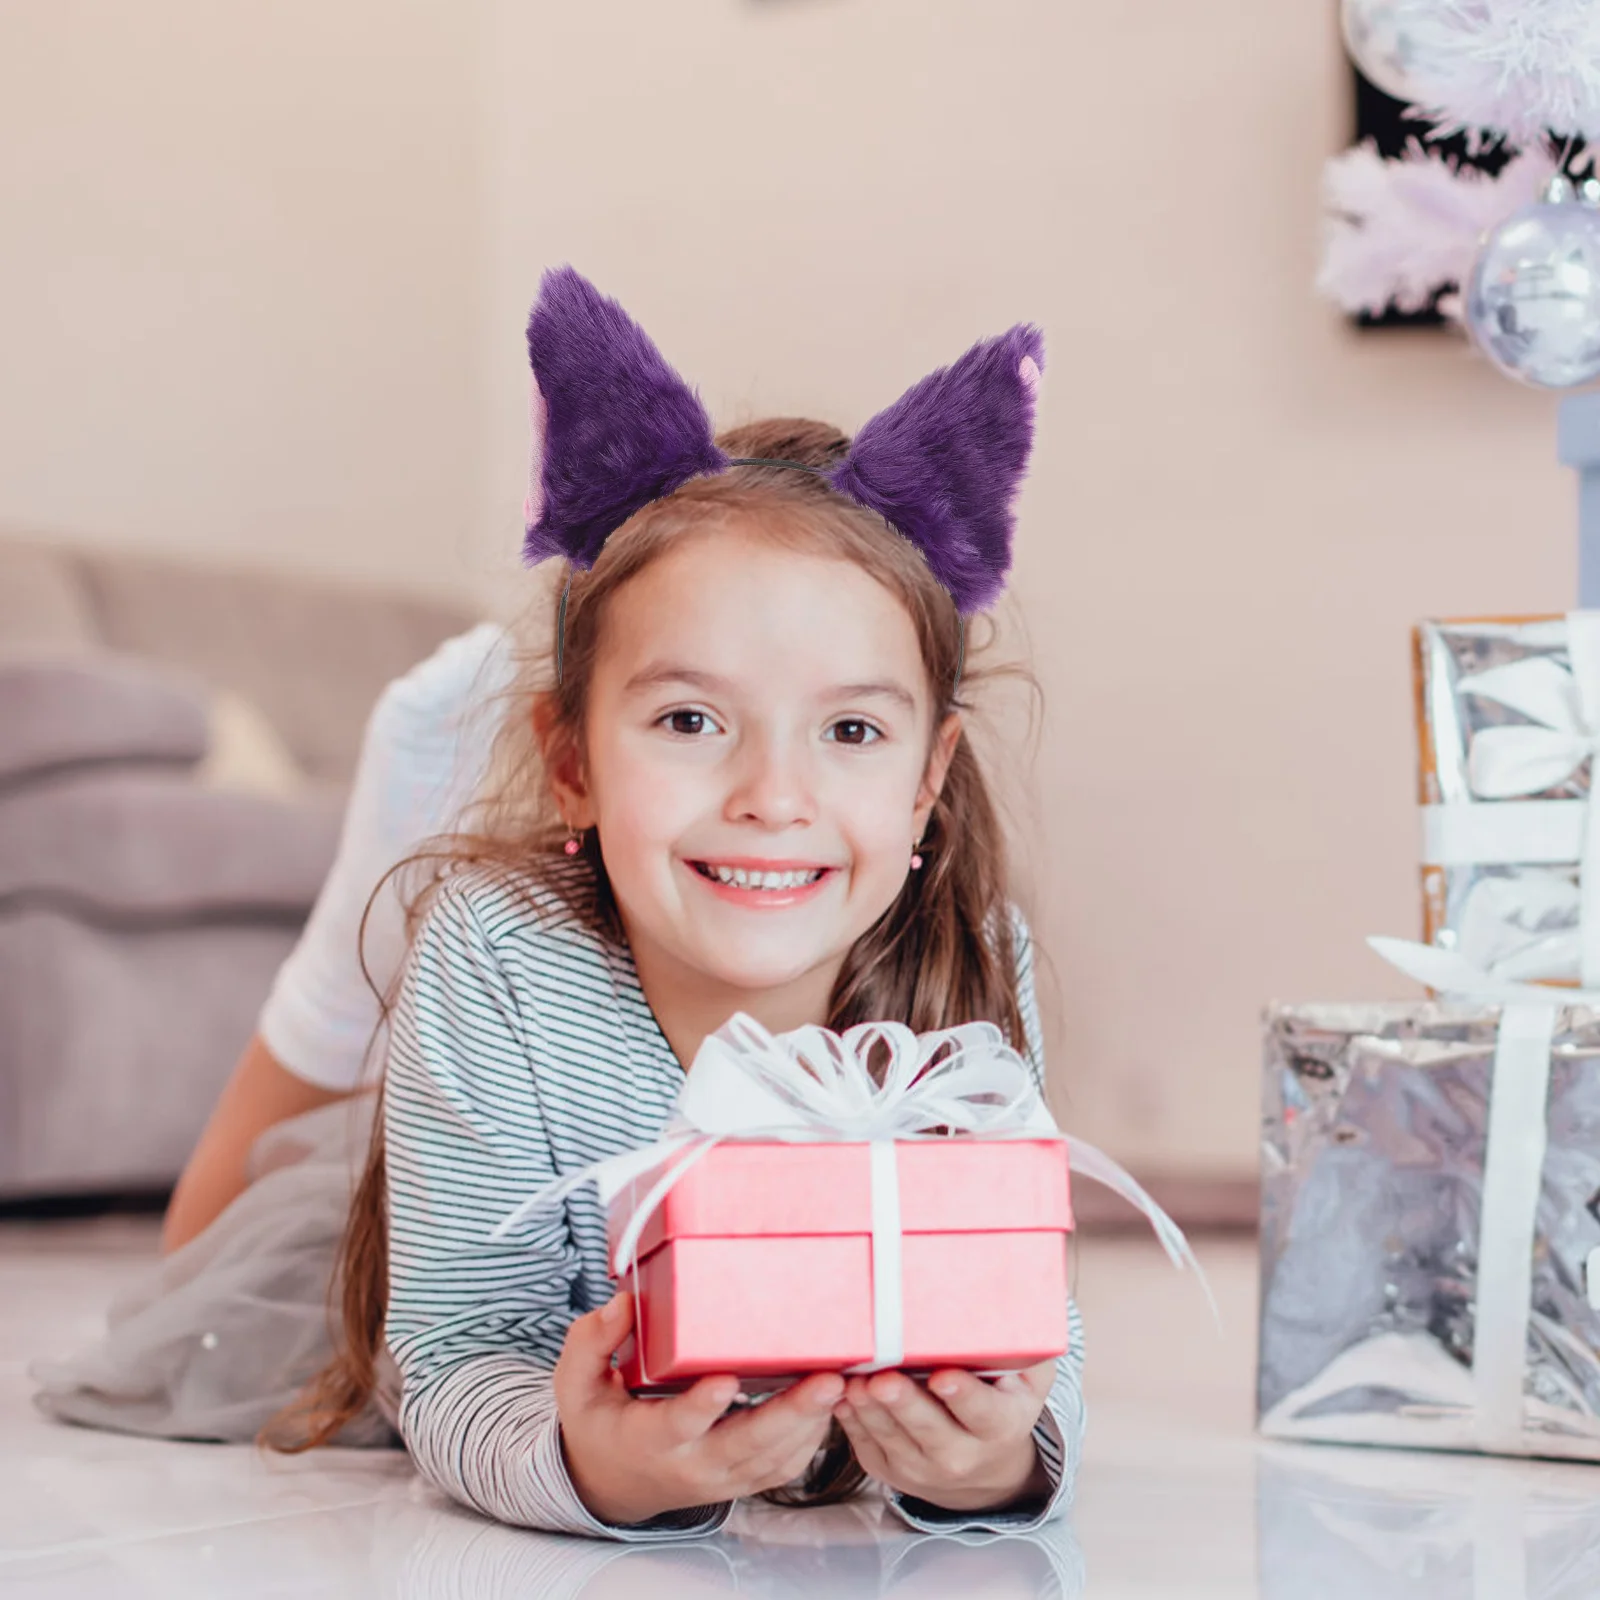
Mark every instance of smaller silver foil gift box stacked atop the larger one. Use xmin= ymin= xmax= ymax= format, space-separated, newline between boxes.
xmin=1413 ymin=616 xmax=1589 ymax=982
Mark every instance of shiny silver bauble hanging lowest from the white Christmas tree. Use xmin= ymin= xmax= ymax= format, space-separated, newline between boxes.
xmin=1462 ymin=178 xmax=1600 ymax=389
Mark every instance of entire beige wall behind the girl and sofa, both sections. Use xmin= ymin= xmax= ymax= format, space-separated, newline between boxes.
xmin=0 ymin=0 xmax=1573 ymax=1171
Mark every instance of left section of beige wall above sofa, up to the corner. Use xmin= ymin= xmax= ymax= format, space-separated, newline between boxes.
xmin=0 ymin=0 xmax=482 ymax=601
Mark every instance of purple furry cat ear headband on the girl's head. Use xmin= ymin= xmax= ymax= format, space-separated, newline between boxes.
xmin=523 ymin=267 xmax=1045 ymax=680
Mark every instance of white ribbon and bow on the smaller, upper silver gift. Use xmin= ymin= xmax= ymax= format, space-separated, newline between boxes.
xmin=1422 ymin=611 xmax=1600 ymax=987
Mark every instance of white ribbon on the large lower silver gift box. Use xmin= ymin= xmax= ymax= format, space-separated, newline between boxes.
xmin=1366 ymin=938 xmax=1580 ymax=1454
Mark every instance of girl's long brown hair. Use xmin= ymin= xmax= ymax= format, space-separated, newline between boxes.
xmin=262 ymin=419 xmax=1027 ymax=1504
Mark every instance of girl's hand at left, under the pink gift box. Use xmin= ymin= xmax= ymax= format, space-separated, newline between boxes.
xmin=555 ymin=1293 xmax=845 ymax=1523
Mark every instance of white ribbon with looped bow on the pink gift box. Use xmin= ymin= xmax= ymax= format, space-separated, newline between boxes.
xmin=491 ymin=1011 xmax=1216 ymax=1371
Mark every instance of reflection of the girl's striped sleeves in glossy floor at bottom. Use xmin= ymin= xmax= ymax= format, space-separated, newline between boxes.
xmin=374 ymin=1502 xmax=1083 ymax=1600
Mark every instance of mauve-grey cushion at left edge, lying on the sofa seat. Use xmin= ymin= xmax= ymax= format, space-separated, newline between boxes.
xmin=0 ymin=653 xmax=210 ymax=786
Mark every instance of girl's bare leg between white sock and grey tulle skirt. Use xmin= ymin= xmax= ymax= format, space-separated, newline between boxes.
xmin=162 ymin=1034 xmax=355 ymax=1253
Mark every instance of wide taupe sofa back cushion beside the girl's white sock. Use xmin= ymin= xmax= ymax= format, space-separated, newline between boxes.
xmin=80 ymin=554 xmax=475 ymax=782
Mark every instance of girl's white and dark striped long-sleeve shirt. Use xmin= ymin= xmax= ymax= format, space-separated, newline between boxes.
xmin=384 ymin=862 xmax=1083 ymax=1539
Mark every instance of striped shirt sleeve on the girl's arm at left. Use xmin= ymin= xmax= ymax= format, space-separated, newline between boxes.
xmin=384 ymin=885 xmax=731 ymax=1539
